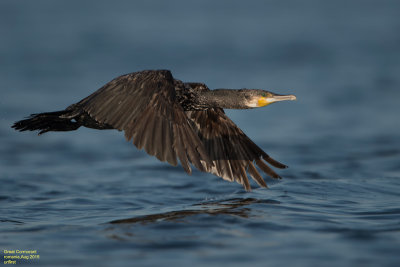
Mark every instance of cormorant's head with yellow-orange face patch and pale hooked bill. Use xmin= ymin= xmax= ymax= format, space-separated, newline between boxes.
xmin=245 ymin=89 xmax=296 ymax=108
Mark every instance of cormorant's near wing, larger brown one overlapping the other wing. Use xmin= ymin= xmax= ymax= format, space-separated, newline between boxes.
xmin=76 ymin=70 xmax=212 ymax=173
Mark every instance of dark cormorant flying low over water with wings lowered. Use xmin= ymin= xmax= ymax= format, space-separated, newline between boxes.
xmin=12 ymin=70 xmax=296 ymax=191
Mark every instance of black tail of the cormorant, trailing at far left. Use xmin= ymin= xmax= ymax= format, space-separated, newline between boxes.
xmin=11 ymin=110 xmax=81 ymax=135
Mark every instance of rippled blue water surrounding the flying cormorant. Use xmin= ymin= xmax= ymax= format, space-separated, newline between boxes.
xmin=0 ymin=0 xmax=400 ymax=266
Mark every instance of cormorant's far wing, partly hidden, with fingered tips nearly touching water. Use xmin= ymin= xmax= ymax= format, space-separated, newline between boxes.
xmin=186 ymin=108 xmax=287 ymax=190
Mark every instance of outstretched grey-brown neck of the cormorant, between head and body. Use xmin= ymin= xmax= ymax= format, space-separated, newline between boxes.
xmin=196 ymin=89 xmax=249 ymax=109
